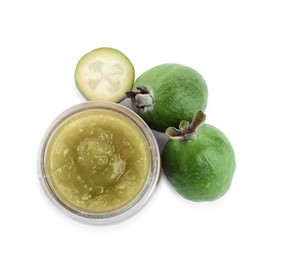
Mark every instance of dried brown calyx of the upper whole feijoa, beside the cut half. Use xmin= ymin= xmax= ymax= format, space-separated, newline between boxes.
xmin=125 ymin=86 xmax=154 ymax=113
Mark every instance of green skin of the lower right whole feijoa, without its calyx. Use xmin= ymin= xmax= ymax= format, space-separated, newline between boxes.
xmin=162 ymin=124 xmax=236 ymax=201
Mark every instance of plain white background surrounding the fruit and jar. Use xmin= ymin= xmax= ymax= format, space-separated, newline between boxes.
xmin=0 ymin=0 xmax=282 ymax=260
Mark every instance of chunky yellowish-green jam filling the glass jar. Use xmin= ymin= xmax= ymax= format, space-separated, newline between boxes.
xmin=46 ymin=109 xmax=150 ymax=213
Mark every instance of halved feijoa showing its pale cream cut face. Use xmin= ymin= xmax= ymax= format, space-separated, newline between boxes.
xmin=75 ymin=47 xmax=134 ymax=102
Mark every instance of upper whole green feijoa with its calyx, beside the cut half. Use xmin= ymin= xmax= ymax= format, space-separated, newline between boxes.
xmin=126 ymin=63 xmax=208 ymax=132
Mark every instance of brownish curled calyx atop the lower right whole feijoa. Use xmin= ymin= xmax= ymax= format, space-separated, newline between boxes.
xmin=165 ymin=110 xmax=206 ymax=141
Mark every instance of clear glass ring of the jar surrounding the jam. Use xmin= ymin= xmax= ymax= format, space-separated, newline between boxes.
xmin=37 ymin=100 xmax=161 ymax=224
